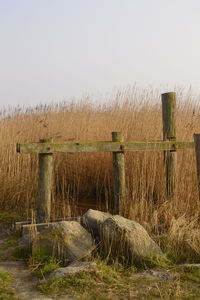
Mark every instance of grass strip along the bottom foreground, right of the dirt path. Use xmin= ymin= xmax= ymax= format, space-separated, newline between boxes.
xmin=38 ymin=260 xmax=200 ymax=300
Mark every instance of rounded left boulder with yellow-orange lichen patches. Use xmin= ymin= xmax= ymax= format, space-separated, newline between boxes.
xmin=36 ymin=221 xmax=95 ymax=265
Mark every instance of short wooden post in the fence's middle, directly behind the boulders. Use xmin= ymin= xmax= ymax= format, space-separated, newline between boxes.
xmin=112 ymin=132 xmax=126 ymax=215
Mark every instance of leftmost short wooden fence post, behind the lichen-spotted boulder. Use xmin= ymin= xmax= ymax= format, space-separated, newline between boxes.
xmin=36 ymin=139 xmax=53 ymax=223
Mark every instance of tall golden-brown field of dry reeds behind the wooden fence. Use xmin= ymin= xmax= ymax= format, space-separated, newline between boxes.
xmin=0 ymin=88 xmax=200 ymax=262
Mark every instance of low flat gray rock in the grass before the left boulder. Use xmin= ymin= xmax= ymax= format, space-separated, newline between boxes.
xmin=43 ymin=261 xmax=98 ymax=281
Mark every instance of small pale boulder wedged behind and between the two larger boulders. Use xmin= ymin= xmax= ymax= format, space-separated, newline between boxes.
xmin=81 ymin=209 xmax=112 ymax=241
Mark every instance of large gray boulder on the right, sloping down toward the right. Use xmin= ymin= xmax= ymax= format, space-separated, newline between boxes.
xmin=101 ymin=215 xmax=163 ymax=264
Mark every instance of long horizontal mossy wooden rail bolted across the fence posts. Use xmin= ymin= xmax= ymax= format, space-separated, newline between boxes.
xmin=17 ymin=141 xmax=194 ymax=154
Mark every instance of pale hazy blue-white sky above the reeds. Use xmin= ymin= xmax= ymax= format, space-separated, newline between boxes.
xmin=0 ymin=0 xmax=200 ymax=107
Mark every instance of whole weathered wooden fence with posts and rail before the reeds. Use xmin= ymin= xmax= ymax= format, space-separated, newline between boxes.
xmin=17 ymin=92 xmax=200 ymax=223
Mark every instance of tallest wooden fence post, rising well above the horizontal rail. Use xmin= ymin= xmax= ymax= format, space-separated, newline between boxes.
xmin=162 ymin=92 xmax=177 ymax=199
